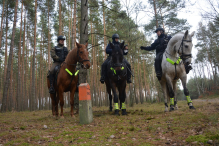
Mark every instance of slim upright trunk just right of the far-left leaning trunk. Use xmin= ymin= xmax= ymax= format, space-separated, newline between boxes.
xmin=16 ymin=0 xmax=24 ymax=111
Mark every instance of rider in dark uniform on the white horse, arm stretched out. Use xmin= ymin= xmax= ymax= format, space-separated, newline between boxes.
xmin=140 ymin=26 xmax=192 ymax=80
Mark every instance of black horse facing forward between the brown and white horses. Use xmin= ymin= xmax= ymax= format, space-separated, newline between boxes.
xmin=105 ymin=42 xmax=127 ymax=115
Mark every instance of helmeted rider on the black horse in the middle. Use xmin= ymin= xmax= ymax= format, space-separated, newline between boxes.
xmin=100 ymin=34 xmax=132 ymax=84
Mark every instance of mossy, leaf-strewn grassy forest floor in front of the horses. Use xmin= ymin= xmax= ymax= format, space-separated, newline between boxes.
xmin=0 ymin=99 xmax=219 ymax=146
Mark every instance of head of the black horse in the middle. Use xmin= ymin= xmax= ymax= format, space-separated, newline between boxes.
xmin=109 ymin=41 xmax=125 ymax=70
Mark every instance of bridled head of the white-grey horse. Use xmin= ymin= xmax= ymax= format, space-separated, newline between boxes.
xmin=178 ymin=30 xmax=195 ymax=65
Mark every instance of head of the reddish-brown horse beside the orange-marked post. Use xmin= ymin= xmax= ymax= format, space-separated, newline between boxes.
xmin=76 ymin=42 xmax=90 ymax=69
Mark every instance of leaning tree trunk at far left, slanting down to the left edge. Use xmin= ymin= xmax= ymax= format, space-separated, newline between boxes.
xmin=1 ymin=0 xmax=18 ymax=112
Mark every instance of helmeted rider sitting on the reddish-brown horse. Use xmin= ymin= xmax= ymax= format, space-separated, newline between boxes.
xmin=49 ymin=35 xmax=68 ymax=94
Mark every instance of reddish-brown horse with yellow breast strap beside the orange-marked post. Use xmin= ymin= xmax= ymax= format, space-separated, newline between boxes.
xmin=47 ymin=42 xmax=90 ymax=118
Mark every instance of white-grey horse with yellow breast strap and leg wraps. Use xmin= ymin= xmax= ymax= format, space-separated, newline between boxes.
xmin=160 ymin=30 xmax=195 ymax=111
